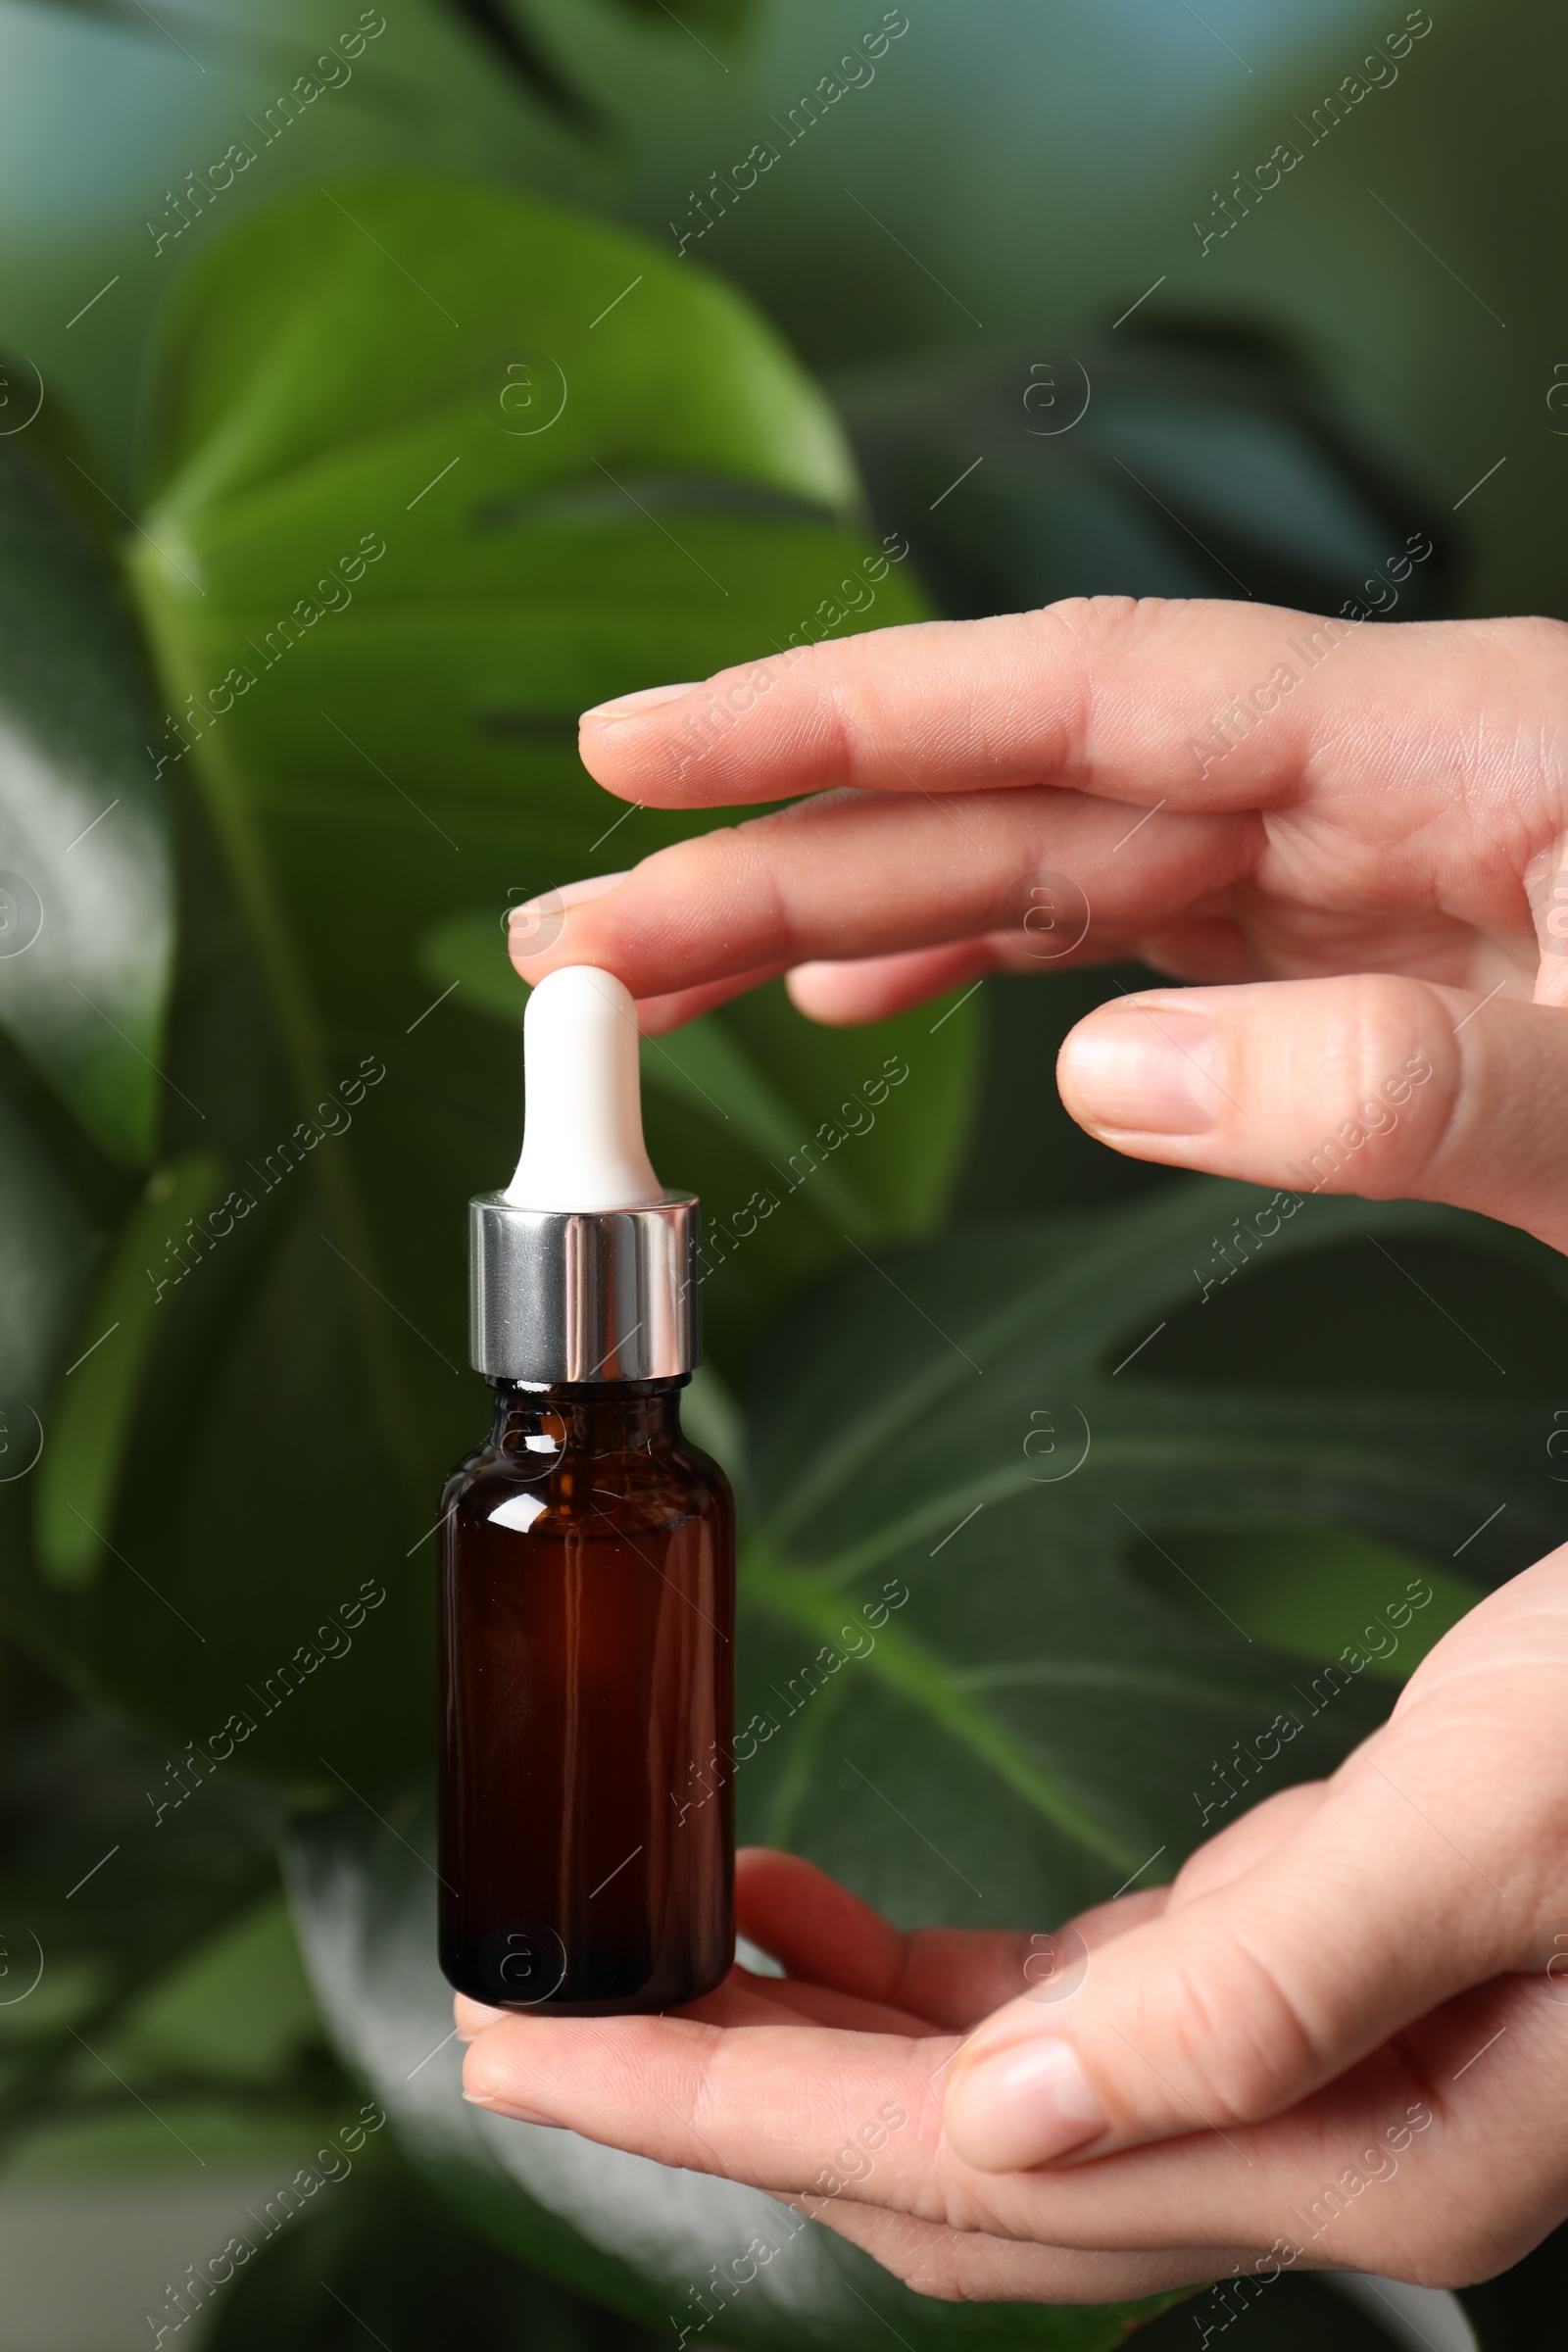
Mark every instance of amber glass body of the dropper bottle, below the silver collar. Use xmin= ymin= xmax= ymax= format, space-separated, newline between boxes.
xmin=440 ymin=1376 xmax=733 ymax=2016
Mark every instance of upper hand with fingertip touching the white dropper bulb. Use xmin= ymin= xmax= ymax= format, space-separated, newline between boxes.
xmin=513 ymin=598 xmax=1568 ymax=1247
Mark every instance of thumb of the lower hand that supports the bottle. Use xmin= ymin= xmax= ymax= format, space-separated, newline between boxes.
xmin=943 ymin=1752 xmax=1514 ymax=2174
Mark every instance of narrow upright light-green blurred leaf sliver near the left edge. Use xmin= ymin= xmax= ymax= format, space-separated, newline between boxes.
xmin=33 ymin=1152 xmax=223 ymax=1586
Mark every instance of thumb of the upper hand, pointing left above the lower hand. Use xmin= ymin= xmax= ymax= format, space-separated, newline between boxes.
xmin=1057 ymin=974 xmax=1568 ymax=1249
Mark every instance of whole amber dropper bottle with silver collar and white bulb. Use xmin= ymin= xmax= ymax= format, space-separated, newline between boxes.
xmin=440 ymin=964 xmax=736 ymax=2016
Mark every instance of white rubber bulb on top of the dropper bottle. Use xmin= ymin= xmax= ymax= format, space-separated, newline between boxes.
xmin=501 ymin=964 xmax=662 ymax=1209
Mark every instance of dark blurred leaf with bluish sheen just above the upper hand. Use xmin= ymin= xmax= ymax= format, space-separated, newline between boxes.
xmin=844 ymin=308 xmax=1457 ymax=621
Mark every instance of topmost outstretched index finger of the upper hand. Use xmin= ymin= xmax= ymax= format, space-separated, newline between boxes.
xmin=578 ymin=598 xmax=1533 ymax=811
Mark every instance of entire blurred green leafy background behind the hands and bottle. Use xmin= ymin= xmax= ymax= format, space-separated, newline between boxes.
xmin=0 ymin=0 xmax=1568 ymax=2352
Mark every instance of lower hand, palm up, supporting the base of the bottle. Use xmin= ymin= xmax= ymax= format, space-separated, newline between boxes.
xmin=456 ymin=1550 xmax=1568 ymax=2303
